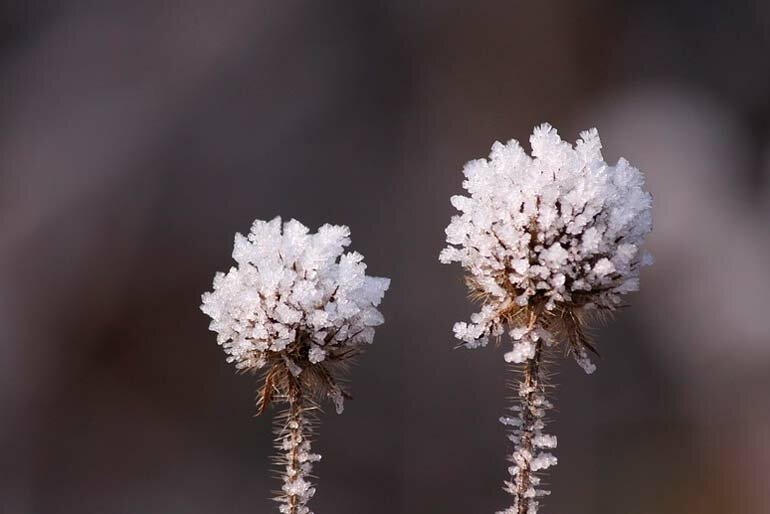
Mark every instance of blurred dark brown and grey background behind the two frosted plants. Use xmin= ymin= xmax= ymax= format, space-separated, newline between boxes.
xmin=0 ymin=0 xmax=770 ymax=514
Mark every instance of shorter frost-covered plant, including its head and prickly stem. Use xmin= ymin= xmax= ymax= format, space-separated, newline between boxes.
xmin=201 ymin=217 xmax=390 ymax=514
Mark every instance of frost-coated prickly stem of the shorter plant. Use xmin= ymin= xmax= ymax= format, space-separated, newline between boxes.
xmin=276 ymin=415 xmax=321 ymax=514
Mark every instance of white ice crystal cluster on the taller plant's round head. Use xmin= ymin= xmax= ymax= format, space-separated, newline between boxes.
xmin=439 ymin=124 xmax=652 ymax=369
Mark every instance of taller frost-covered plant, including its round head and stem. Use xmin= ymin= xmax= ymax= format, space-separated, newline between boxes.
xmin=439 ymin=124 xmax=652 ymax=514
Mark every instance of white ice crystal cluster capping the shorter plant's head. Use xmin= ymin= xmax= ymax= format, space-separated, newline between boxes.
xmin=201 ymin=217 xmax=390 ymax=400
